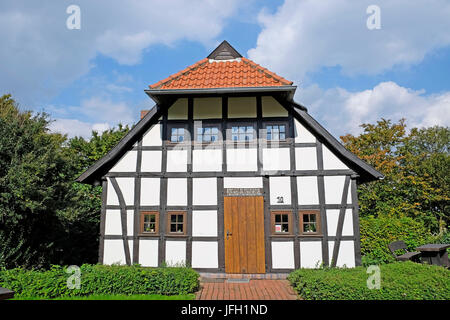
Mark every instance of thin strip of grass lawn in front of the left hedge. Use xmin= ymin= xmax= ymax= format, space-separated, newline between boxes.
xmin=11 ymin=294 xmax=195 ymax=300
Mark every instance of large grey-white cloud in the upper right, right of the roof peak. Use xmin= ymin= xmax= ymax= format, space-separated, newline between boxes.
xmin=248 ymin=0 xmax=450 ymax=80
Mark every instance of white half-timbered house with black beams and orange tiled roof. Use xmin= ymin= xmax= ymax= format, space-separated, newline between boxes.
xmin=77 ymin=41 xmax=382 ymax=273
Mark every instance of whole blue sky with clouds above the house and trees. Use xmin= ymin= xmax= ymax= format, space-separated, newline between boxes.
xmin=0 ymin=0 xmax=450 ymax=137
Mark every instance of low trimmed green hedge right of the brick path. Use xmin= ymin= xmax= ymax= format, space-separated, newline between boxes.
xmin=288 ymin=262 xmax=450 ymax=300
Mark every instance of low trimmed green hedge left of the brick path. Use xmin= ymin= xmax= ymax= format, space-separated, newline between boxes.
xmin=0 ymin=264 xmax=199 ymax=298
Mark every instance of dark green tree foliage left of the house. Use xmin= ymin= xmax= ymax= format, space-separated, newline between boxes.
xmin=0 ymin=95 xmax=128 ymax=267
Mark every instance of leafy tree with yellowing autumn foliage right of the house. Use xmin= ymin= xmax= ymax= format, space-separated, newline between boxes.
xmin=341 ymin=119 xmax=450 ymax=232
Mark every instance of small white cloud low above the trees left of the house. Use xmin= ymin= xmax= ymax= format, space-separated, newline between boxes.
xmin=49 ymin=119 xmax=110 ymax=139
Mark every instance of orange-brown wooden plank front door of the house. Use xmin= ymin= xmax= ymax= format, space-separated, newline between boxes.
xmin=224 ymin=196 xmax=266 ymax=273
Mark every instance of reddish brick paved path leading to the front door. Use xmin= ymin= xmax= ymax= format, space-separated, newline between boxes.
xmin=196 ymin=280 xmax=297 ymax=300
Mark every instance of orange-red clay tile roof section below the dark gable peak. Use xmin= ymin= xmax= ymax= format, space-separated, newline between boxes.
xmin=149 ymin=58 xmax=292 ymax=90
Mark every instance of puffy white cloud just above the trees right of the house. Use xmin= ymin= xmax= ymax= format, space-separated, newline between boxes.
xmin=297 ymin=82 xmax=450 ymax=136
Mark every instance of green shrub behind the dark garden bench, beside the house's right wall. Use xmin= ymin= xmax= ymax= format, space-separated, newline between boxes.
xmin=360 ymin=216 xmax=433 ymax=265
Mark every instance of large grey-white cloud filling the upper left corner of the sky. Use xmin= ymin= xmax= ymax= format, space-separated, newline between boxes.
xmin=0 ymin=0 xmax=239 ymax=105
